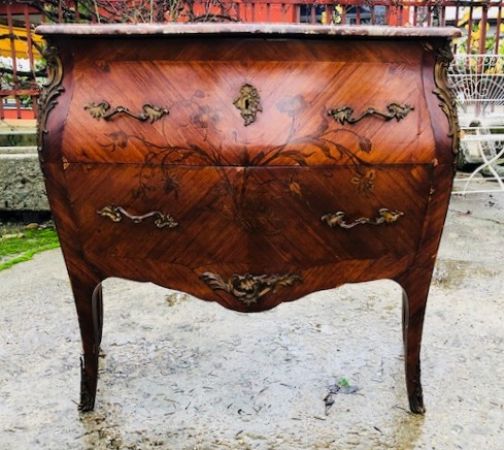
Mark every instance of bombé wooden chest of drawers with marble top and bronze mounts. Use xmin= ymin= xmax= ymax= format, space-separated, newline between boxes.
xmin=38 ymin=24 xmax=458 ymax=413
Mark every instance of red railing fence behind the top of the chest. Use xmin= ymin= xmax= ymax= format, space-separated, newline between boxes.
xmin=0 ymin=0 xmax=504 ymax=120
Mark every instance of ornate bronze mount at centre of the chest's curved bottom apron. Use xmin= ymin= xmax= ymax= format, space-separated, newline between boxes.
xmin=201 ymin=272 xmax=303 ymax=306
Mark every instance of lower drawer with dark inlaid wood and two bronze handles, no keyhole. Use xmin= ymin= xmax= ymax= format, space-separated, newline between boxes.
xmin=65 ymin=163 xmax=432 ymax=270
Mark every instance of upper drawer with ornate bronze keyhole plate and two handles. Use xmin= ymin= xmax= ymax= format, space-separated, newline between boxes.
xmin=63 ymin=39 xmax=435 ymax=166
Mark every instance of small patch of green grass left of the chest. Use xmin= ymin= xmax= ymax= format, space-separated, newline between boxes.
xmin=0 ymin=228 xmax=59 ymax=271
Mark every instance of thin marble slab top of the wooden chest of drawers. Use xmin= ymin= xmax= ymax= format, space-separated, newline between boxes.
xmin=35 ymin=23 xmax=461 ymax=38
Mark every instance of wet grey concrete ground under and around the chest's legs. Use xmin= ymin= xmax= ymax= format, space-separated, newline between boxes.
xmin=0 ymin=194 xmax=504 ymax=450
